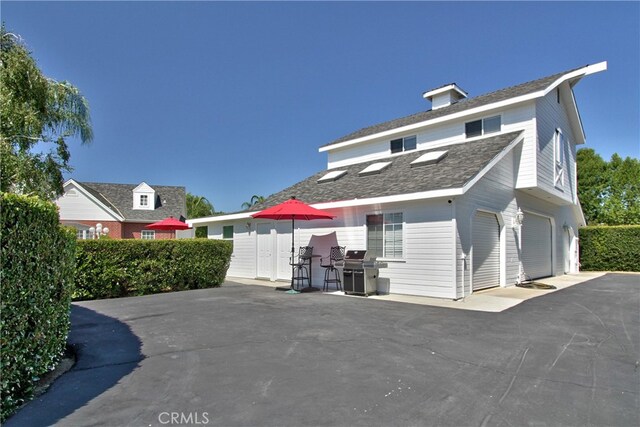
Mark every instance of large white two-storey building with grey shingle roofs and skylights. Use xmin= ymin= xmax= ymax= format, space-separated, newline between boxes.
xmin=189 ymin=62 xmax=606 ymax=299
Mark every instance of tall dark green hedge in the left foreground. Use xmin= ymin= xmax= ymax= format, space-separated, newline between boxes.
xmin=0 ymin=193 xmax=76 ymax=420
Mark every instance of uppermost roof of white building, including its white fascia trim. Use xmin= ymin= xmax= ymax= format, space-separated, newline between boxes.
xmin=320 ymin=62 xmax=606 ymax=151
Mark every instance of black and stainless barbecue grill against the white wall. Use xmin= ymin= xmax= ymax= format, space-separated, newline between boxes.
xmin=336 ymin=250 xmax=387 ymax=295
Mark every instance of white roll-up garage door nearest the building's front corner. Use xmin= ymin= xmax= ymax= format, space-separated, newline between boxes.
xmin=473 ymin=212 xmax=500 ymax=290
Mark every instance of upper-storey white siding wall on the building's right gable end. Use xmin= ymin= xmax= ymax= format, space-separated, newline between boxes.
xmin=536 ymin=83 xmax=576 ymax=202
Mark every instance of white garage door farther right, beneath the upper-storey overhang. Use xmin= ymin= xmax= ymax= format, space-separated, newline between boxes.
xmin=522 ymin=212 xmax=552 ymax=279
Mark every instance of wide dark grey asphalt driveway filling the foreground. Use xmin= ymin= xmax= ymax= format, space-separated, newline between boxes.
xmin=7 ymin=274 xmax=640 ymax=426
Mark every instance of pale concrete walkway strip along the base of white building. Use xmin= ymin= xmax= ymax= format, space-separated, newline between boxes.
xmin=227 ymin=272 xmax=606 ymax=313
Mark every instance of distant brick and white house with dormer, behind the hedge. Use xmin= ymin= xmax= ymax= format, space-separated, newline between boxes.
xmin=56 ymin=179 xmax=187 ymax=239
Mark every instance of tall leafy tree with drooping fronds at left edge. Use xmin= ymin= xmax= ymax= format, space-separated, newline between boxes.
xmin=0 ymin=24 xmax=93 ymax=199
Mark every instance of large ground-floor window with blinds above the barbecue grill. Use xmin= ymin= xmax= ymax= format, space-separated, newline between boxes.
xmin=367 ymin=212 xmax=404 ymax=258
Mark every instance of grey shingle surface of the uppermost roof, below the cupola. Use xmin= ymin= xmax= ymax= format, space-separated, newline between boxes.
xmin=323 ymin=67 xmax=582 ymax=147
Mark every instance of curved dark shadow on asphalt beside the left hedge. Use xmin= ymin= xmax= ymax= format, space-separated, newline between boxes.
xmin=5 ymin=304 xmax=144 ymax=426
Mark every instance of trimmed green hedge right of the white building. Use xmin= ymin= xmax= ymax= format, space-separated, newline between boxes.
xmin=580 ymin=225 xmax=640 ymax=271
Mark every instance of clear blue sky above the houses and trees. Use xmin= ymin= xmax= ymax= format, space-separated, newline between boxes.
xmin=1 ymin=1 xmax=640 ymax=212
